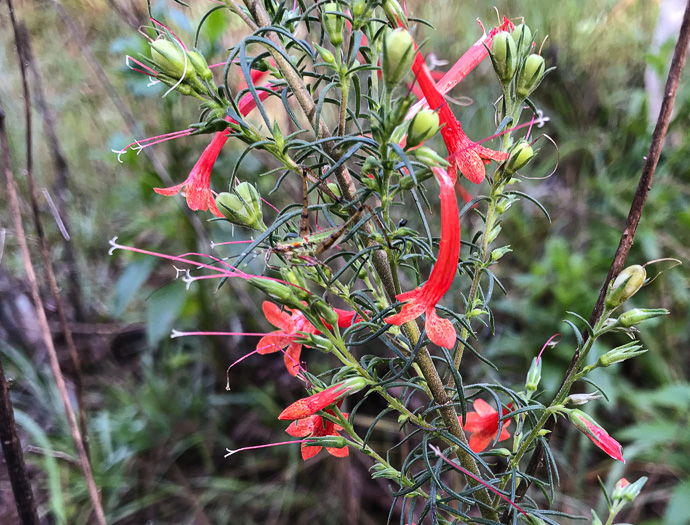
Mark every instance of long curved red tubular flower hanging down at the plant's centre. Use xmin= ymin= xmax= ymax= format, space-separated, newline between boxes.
xmin=384 ymin=168 xmax=460 ymax=348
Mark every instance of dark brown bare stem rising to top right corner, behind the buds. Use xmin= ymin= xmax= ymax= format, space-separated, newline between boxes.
xmin=503 ymin=0 xmax=690 ymax=512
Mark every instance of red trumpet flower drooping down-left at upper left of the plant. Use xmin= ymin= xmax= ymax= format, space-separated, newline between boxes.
xmin=153 ymin=73 xmax=279 ymax=217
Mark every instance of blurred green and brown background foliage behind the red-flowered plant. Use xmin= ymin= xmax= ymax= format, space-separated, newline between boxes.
xmin=0 ymin=0 xmax=690 ymax=525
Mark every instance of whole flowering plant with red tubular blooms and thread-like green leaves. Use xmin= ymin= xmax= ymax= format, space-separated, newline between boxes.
xmin=112 ymin=0 xmax=666 ymax=523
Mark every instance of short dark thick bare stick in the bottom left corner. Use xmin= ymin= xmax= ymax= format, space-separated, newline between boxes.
xmin=0 ymin=352 xmax=39 ymax=525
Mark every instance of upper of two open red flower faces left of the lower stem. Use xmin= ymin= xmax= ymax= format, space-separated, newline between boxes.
xmin=256 ymin=301 xmax=318 ymax=376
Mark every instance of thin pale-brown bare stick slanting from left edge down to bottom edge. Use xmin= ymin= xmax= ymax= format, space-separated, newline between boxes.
xmin=0 ymin=101 xmax=106 ymax=525
